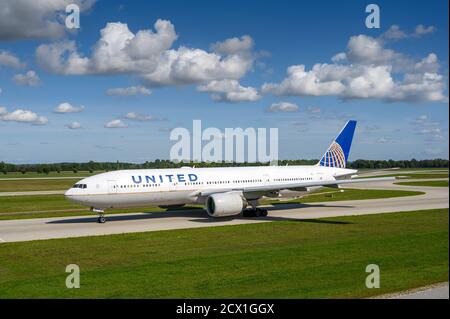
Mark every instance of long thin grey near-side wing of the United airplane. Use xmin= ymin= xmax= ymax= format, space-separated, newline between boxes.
xmin=199 ymin=177 xmax=395 ymax=196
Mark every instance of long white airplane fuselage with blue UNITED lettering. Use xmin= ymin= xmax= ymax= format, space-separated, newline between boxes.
xmin=65 ymin=166 xmax=356 ymax=209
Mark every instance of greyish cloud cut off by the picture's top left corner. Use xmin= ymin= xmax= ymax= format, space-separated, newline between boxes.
xmin=0 ymin=0 xmax=95 ymax=41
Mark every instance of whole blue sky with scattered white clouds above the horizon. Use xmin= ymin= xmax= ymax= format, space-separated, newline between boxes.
xmin=0 ymin=0 xmax=449 ymax=163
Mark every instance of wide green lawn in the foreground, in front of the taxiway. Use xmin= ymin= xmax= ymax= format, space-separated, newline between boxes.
xmin=0 ymin=209 xmax=449 ymax=298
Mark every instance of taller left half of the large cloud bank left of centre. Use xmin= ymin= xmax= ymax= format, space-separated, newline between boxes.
xmin=36 ymin=20 xmax=177 ymax=75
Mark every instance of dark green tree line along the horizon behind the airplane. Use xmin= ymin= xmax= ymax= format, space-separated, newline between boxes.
xmin=0 ymin=158 xmax=448 ymax=174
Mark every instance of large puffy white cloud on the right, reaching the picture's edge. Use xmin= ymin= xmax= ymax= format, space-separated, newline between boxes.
xmin=262 ymin=30 xmax=448 ymax=102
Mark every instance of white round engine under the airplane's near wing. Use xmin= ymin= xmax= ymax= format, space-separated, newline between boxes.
xmin=206 ymin=192 xmax=247 ymax=217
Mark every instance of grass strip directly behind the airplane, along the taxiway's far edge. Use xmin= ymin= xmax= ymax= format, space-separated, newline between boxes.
xmin=0 ymin=188 xmax=423 ymax=220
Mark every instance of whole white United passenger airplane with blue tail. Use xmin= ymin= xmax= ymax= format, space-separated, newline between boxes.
xmin=64 ymin=120 xmax=394 ymax=223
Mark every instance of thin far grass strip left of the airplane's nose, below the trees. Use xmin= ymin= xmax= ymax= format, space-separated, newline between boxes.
xmin=0 ymin=180 xmax=77 ymax=192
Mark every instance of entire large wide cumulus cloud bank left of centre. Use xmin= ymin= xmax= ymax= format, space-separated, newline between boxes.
xmin=36 ymin=19 xmax=254 ymax=91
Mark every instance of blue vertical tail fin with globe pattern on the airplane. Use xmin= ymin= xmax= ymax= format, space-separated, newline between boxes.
xmin=317 ymin=120 xmax=356 ymax=168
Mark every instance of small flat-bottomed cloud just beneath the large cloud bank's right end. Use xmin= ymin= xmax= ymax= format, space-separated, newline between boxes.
xmin=197 ymin=80 xmax=261 ymax=103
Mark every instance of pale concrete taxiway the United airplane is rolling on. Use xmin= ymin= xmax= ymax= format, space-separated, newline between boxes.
xmin=0 ymin=182 xmax=449 ymax=242
